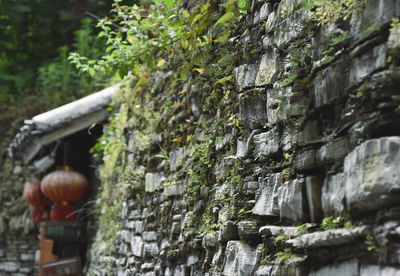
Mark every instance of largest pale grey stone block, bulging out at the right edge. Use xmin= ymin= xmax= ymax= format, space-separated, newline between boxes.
xmin=344 ymin=136 xmax=400 ymax=212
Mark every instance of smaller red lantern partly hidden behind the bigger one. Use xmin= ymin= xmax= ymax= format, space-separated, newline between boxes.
xmin=23 ymin=180 xmax=51 ymax=222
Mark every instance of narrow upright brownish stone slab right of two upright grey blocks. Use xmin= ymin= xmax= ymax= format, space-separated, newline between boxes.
xmin=306 ymin=176 xmax=324 ymax=222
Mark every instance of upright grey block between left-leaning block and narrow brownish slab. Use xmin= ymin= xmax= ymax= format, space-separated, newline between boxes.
xmin=278 ymin=178 xmax=307 ymax=222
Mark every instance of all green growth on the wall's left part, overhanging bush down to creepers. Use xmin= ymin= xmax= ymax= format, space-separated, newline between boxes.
xmin=81 ymin=0 xmax=248 ymax=256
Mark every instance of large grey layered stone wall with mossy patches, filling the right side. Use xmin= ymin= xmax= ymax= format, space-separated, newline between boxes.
xmin=88 ymin=0 xmax=400 ymax=276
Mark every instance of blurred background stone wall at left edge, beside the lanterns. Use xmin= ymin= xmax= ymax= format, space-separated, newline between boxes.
xmin=0 ymin=158 xmax=39 ymax=276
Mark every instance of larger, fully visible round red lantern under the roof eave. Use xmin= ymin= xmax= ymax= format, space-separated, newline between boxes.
xmin=41 ymin=166 xmax=89 ymax=221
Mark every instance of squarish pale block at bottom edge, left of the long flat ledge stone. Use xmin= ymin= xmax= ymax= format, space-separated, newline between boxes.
xmin=223 ymin=241 xmax=260 ymax=276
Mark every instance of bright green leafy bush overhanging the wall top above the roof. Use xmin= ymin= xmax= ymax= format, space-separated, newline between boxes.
xmin=70 ymin=0 xmax=246 ymax=78
